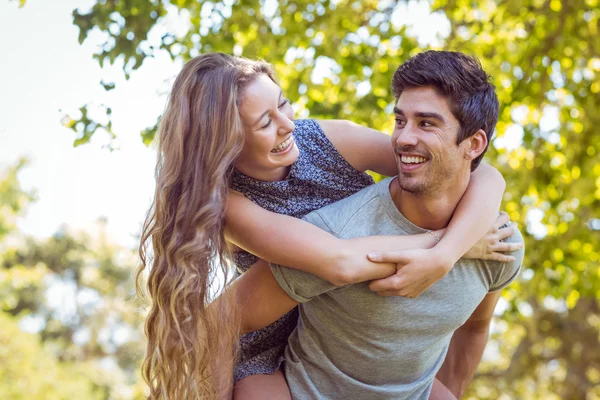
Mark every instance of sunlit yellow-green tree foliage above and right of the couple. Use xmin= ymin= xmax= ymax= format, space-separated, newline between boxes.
xmin=8 ymin=0 xmax=600 ymax=399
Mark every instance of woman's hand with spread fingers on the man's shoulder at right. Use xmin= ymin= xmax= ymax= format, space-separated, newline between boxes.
xmin=464 ymin=212 xmax=523 ymax=262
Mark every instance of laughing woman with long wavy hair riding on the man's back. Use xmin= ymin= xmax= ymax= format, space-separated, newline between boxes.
xmin=138 ymin=53 xmax=511 ymax=399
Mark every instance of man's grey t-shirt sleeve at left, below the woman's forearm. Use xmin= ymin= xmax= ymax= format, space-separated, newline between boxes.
xmin=271 ymin=211 xmax=337 ymax=303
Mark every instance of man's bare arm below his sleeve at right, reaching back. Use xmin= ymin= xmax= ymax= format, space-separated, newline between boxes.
xmin=436 ymin=291 xmax=500 ymax=398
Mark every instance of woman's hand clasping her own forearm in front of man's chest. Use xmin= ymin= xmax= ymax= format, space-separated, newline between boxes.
xmin=369 ymin=247 xmax=456 ymax=298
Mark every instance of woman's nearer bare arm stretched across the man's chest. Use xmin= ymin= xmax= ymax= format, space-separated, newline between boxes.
xmin=225 ymin=191 xmax=443 ymax=286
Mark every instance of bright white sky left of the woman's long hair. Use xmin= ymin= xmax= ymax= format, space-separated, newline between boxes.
xmin=0 ymin=0 xmax=180 ymax=246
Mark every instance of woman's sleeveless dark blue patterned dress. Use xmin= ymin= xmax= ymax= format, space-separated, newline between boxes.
xmin=230 ymin=119 xmax=373 ymax=382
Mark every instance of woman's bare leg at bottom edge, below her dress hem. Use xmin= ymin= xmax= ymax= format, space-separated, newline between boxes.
xmin=233 ymin=370 xmax=292 ymax=400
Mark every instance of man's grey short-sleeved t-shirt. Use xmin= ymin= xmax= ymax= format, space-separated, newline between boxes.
xmin=271 ymin=178 xmax=523 ymax=400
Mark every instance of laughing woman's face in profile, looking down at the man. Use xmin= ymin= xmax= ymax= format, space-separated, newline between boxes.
xmin=235 ymin=74 xmax=298 ymax=181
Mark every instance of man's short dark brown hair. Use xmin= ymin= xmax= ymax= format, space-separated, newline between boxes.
xmin=392 ymin=50 xmax=499 ymax=171
